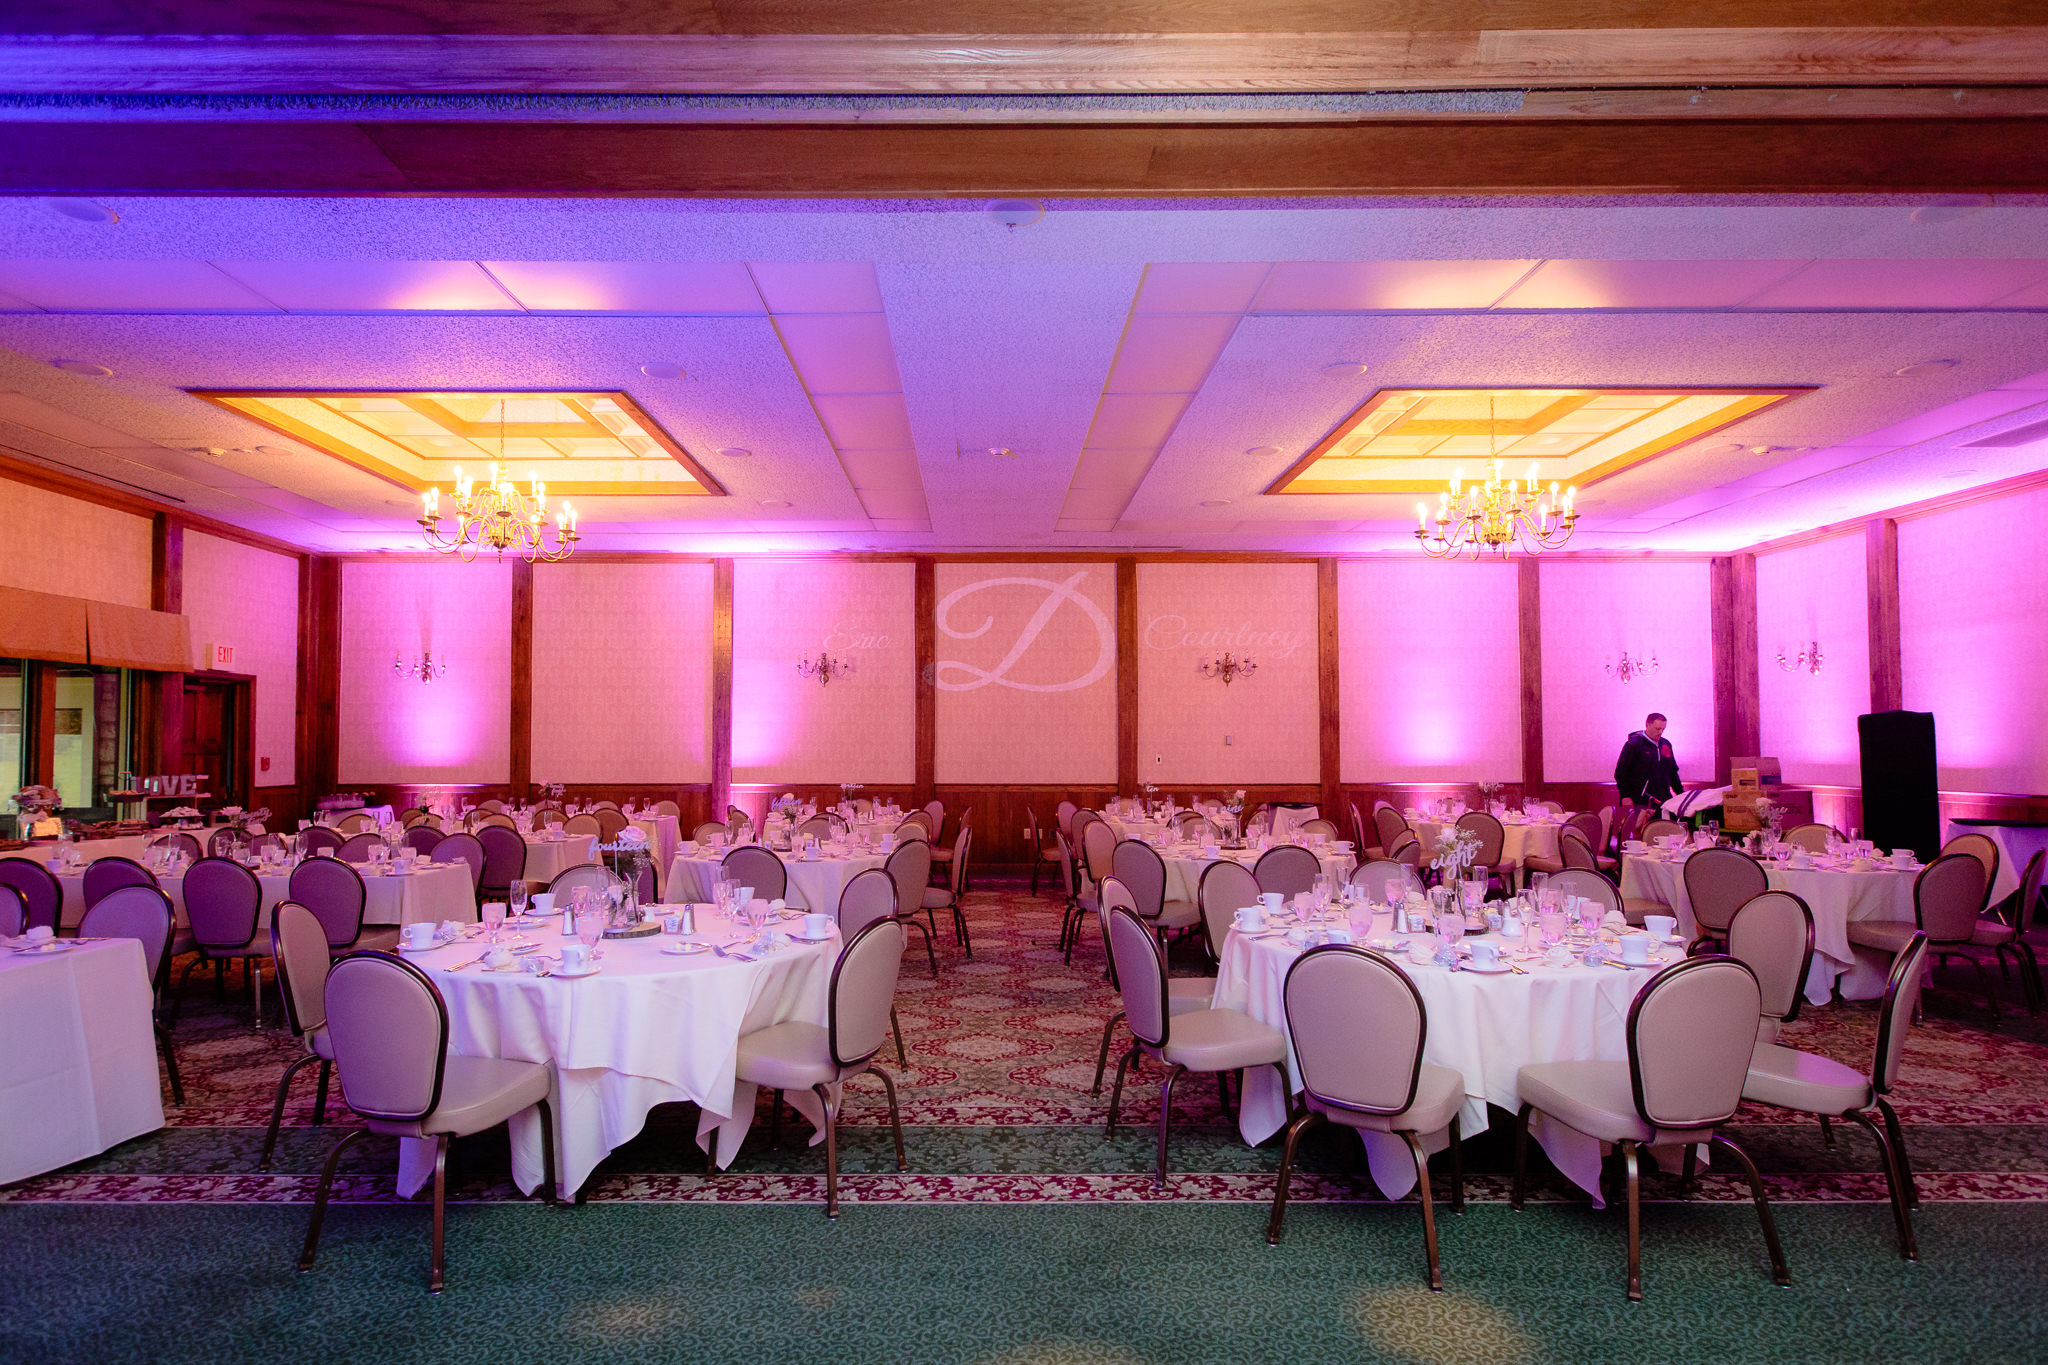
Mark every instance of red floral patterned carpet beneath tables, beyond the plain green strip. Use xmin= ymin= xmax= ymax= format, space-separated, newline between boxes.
xmin=0 ymin=882 xmax=2048 ymax=1220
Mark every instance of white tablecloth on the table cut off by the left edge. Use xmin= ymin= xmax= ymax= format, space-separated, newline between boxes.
xmin=0 ymin=939 xmax=164 ymax=1185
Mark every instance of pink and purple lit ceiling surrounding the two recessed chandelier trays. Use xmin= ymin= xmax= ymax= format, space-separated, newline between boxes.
xmin=0 ymin=196 xmax=2048 ymax=553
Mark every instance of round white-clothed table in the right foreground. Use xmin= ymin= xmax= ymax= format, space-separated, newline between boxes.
xmin=1214 ymin=911 xmax=1677 ymax=1207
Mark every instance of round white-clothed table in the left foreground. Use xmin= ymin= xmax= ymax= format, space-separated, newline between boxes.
xmin=397 ymin=905 xmax=840 ymax=1197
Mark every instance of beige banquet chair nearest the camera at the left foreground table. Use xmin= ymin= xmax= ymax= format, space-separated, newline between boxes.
xmin=299 ymin=952 xmax=555 ymax=1293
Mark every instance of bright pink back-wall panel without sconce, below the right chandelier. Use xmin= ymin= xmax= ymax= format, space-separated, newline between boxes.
xmin=1337 ymin=557 xmax=1522 ymax=782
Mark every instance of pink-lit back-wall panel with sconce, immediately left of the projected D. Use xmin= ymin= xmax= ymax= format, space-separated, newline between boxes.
xmin=733 ymin=559 xmax=918 ymax=786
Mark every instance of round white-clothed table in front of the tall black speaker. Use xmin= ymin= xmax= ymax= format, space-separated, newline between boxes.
xmin=1622 ymin=853 xmax=1921 ymax=1005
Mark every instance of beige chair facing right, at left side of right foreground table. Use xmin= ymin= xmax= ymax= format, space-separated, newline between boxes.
xmin=1102 ymin=898 xmax=1288 ymax=1187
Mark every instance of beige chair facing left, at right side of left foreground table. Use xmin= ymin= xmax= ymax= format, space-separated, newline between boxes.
xmin=733 ymin=917 xmax=909 ymax=1218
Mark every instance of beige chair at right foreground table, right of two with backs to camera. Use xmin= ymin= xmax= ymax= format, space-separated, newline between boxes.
xmin=1509 ymin=956 xmax=1792 ymax=1302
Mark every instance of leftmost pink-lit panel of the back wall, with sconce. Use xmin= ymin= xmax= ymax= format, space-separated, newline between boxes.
xmin=338 ymin=561 xmax=512 ymax=786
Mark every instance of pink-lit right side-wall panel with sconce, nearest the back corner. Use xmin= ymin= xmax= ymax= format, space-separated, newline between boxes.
xmin=1757 ymin=534 xmax=1870 ymax=786
